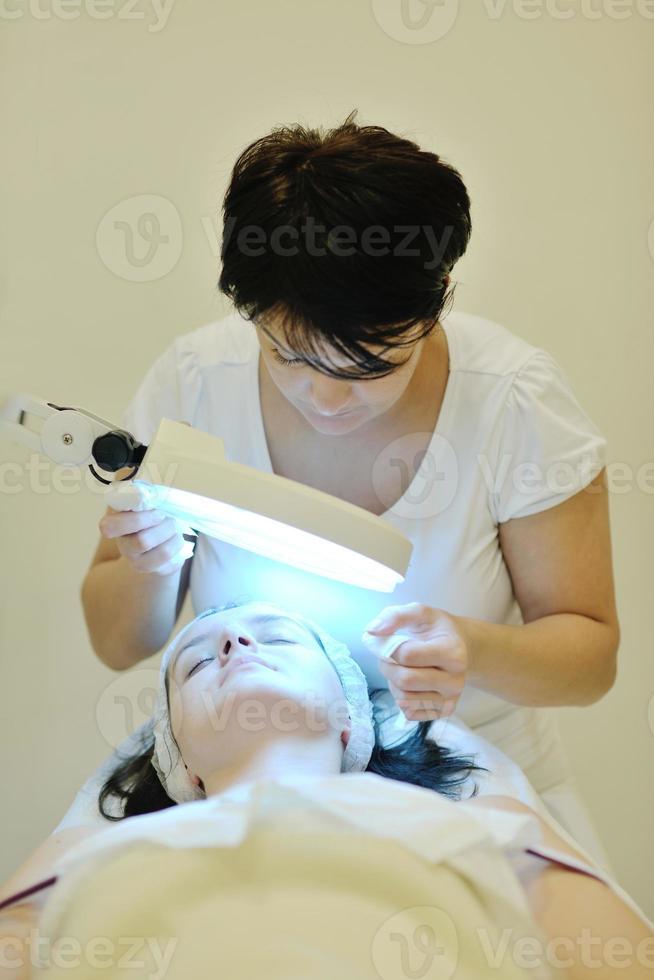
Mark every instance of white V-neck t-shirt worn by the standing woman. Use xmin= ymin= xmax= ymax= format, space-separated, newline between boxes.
xmin=123 ymin=311 xmax=606 ymax=789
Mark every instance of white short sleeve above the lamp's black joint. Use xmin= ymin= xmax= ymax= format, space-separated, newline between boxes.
xmin=122 ymin=338 xmax=202 ymax=445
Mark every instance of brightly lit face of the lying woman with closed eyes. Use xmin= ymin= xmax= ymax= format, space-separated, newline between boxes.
xmin=168 ymin=602 xmax=349 ymax=783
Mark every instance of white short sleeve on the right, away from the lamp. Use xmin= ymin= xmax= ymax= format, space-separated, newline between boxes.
xmin=490 ymin=351 xmax=607 ymax=524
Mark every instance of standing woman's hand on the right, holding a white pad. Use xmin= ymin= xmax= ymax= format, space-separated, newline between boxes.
xmin=366 ymin=602 xmax=470 ymax=721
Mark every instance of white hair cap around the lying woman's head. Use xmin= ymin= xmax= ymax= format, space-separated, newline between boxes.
xmin=152 ymin=603 xmax=375 ymax=803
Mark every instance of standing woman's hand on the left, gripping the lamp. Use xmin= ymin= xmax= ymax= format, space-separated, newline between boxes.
xmin=99 ymin=507 xmax=193 ymax=575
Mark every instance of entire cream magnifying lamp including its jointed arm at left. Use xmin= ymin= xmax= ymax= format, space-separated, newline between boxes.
xmin=0 ymin=394 xmax=413 ymax=592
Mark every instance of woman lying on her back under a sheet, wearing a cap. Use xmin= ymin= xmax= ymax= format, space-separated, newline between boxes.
xmin=0 ymin=602 xmax=654 ymax=980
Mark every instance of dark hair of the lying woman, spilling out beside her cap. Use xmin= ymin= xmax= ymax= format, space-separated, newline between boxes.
xmin=98 ymin=602 xmax=488 ymax=820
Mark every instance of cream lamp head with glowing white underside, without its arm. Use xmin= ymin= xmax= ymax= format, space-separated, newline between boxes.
xmin=134 ymin=419 xmax=413 ymax=592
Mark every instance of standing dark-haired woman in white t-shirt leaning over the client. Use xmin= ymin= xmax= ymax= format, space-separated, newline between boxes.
xmin=82 ymin=114 xmax=619 ymax=866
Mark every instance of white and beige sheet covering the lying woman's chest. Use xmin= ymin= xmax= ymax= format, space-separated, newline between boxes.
xmin=39 ymin=773 xmax=654 ymax=980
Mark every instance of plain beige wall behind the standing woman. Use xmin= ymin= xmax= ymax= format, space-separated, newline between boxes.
xmin=0 ymin=0 xmax=654 ymax=916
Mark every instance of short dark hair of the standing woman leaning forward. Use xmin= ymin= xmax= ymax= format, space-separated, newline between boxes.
xmin=218 ymin=109 xmax=471 ymax=378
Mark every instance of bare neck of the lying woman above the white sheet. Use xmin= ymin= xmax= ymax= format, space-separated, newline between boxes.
xmin=202 ymin=736 xmax=343 ymax=799
